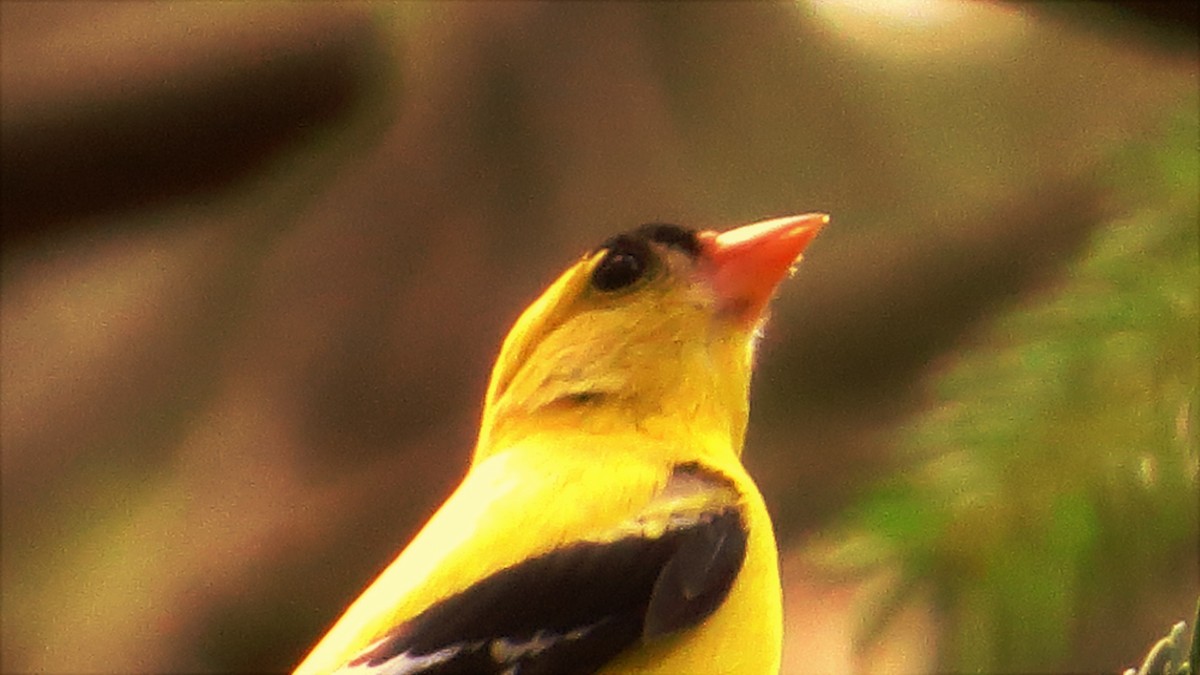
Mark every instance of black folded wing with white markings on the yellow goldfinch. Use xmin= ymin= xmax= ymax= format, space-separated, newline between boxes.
xmin=348 ymin=494 xmax=746 ymax=675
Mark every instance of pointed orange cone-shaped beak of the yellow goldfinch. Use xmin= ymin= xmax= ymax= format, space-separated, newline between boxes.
xmin=700 ymin=214 xmax=829 ymax=324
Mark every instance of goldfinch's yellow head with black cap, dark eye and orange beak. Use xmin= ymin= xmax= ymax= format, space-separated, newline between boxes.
xmin=475 ymin=214 xmax=829 ymax=461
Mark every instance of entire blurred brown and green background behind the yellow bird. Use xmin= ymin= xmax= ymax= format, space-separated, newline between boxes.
xmin=0 ymin=0 xmax=1200 ymax=674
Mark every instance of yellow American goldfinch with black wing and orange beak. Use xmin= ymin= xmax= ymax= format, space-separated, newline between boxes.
xmin=295 ymin=214 xmax=828 ymax=675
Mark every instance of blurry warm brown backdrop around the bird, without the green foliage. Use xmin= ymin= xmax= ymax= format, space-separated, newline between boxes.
xmin=0 ymin=2 xmax=1198 ymax=673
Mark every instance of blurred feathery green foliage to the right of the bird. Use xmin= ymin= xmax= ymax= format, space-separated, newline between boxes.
xmin=836 ymin=102 xmax=1200 ymax=671
